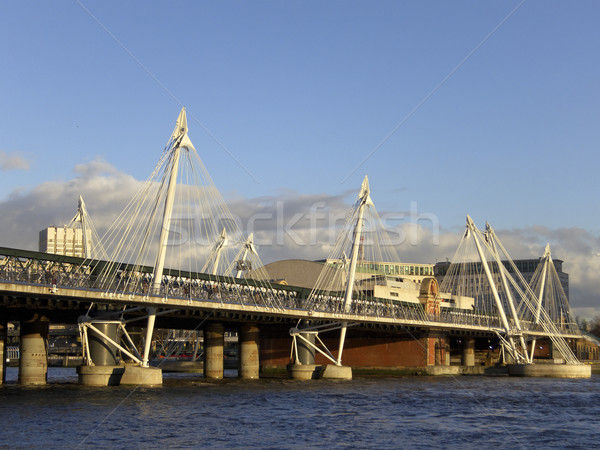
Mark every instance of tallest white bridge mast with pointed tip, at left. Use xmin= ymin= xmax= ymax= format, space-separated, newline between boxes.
xmin=142 ymin=107 xmax=194 ymax=367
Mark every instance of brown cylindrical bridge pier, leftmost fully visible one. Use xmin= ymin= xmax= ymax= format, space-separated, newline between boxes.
xmin=19 ymin=314 xmax=50 ymax=386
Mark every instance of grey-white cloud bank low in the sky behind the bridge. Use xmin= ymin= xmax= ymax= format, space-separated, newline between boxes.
xmin=0 ymin=160 xmax=600 ymax=317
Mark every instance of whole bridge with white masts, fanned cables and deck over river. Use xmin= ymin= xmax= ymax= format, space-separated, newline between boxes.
xmin=0 ymin=109 xmax=580 ymax=381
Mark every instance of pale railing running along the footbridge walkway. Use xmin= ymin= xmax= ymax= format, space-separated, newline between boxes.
xmin=0 ymin=261 xmax=524 ymax=328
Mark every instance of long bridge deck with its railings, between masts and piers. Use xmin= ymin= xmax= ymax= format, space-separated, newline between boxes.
xmin=0 ymin=247 xmax=580 ymax=338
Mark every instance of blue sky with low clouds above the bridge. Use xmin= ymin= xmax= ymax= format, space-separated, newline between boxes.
xmin=0 ymin=0 xmax=600 ymax=316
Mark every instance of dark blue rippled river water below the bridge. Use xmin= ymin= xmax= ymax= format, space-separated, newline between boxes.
xmin=0 ymin=368 xmax=600 ymax=449
